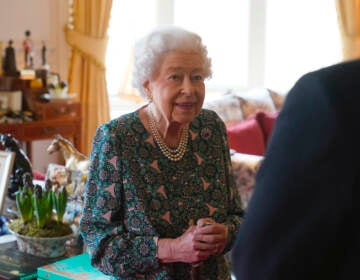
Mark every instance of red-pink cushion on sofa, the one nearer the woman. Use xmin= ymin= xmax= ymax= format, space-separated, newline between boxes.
xmin=227 ymin=118 xmax=265 ymax=155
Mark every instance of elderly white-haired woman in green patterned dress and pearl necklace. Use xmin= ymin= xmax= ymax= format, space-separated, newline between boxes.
xmin=81 ymin=26 xmax=242 ymax=280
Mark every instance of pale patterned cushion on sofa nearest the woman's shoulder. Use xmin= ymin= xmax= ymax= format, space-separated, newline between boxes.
xmin=204 ymin=93 xmax=243 ymax=126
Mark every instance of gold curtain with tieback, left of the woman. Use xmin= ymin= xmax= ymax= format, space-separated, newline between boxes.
xmin=65 ymin=0 xmax=112 ymax=155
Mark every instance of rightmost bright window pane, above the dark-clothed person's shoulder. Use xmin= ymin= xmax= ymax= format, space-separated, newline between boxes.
xmin=264 ymin=0 xmax=341 ymax=92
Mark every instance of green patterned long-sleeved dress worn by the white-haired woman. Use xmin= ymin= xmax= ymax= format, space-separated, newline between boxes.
xmin=80 ymin=109 xmax=243 ymax=280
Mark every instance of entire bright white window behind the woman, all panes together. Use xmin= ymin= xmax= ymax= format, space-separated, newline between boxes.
xmin=106 ymin=0 xmax=341 ymax=117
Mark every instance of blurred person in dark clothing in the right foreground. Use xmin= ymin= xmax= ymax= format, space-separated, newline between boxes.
xmin=232 ymin=60 xmax=360 ymax=280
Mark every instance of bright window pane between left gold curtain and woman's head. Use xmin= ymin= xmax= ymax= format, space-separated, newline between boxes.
xmin=106 ymin=0 xmax=156 ymax=118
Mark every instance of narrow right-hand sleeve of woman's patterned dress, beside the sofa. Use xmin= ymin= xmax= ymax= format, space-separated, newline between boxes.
xmin=220 ymin=117 xmax=244 ymax=252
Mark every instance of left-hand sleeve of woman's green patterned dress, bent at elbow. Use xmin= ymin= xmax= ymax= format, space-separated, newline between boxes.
xmin=80 ymin=124 xmax=159 ymax=277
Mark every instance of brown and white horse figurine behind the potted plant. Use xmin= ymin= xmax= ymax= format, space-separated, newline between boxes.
xmin=47 ymin=134 xmax=89 ymax=173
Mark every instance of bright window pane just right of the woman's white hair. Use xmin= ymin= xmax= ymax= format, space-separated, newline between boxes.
xmin=174 ymin=0 xmax=249 ymax=91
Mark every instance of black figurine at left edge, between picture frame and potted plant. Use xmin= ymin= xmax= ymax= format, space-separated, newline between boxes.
xmin=0 ymin=133 xmax=32 ymax=199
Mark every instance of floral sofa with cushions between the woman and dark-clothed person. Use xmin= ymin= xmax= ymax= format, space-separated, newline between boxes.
xmin=204 ymin=88 xmax=286 ymax=209
